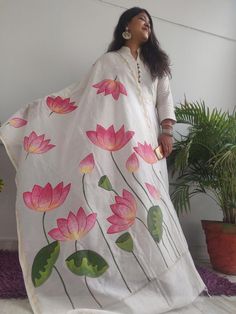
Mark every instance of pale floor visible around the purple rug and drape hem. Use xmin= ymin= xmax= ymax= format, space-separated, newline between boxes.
xmin=0 ymin=260 xmax=236 ymax=314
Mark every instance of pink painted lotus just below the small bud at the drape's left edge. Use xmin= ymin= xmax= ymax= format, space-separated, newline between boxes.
xmin=24 ymin=131 xmax=56 ymax=154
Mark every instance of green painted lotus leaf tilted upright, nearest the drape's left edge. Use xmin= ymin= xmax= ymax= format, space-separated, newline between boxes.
xmin=31 ymin=241 xmax=60 ymax=287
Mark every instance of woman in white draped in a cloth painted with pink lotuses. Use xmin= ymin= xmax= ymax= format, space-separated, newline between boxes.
xmin=1 ymin=4 xmax=204 ymax=314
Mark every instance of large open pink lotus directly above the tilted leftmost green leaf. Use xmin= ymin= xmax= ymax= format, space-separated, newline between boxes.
xmin=23 ymin=182 xmax=71 ymax=212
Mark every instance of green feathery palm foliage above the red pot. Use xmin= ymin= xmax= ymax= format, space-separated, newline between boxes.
xmin=168 ymin=99 xmax=236 ymax=223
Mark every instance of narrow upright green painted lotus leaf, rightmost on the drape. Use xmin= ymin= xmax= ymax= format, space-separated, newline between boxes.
xmin=147 ymin=206 xmax=163 ymax=242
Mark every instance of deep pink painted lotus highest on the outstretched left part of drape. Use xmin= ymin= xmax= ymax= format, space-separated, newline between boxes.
xmin=46 ymin=96 xmax=78 ymax=114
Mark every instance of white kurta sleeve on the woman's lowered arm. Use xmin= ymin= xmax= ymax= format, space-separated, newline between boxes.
xmin=156 ymin=75 xmax=176 ymax=123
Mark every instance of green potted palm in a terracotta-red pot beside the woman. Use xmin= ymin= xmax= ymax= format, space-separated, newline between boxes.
xmin=168 ymin=100 xmax=236 ymax=275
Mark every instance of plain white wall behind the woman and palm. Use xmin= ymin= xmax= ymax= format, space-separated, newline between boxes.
xmin=0 ymin=0 xmax=236 ymax=254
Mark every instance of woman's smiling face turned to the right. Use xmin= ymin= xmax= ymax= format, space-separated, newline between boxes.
xmin=128 ymin=12 xmax=151 ymax=43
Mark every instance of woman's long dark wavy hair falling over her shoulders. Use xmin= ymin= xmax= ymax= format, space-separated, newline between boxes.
xmin=107 ymin=7 xmax=171 ymax=80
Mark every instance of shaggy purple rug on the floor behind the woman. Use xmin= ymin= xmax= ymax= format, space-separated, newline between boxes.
xmin=0 ymin=250 xmax=236 ymax=299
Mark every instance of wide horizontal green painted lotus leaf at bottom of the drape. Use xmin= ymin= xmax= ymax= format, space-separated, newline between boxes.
xmin=66 ymin=250 xmax=109 ymax=278
